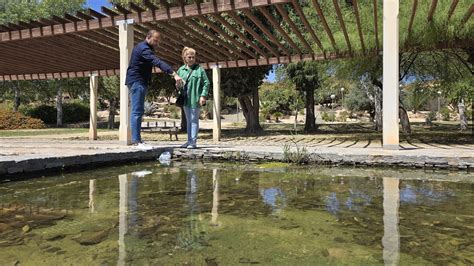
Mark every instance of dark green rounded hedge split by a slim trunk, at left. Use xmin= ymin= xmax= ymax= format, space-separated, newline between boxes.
xmin=23 ymin=102 xmax=90 ymax=124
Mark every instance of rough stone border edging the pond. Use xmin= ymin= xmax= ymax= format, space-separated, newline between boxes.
xmin=0 ymin=148 xmax=474 ymax=180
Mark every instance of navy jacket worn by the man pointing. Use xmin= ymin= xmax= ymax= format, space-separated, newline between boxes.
xmin=125 ymin=41 xmax=173 ymax=86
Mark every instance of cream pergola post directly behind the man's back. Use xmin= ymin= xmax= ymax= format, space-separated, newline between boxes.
xmin=117 ymin=19 xmax=133 ymax=145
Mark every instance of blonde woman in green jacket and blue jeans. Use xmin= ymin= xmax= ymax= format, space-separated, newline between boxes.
xmin=177 ymin=47 xmax=209 ymax=149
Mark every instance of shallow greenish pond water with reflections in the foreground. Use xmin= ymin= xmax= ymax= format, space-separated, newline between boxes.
xmin=0 ymin=162 xmax=474 ymax=265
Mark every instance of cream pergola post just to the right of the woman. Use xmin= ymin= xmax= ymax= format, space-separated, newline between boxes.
xmin=212 ymin=65 xmax=221 ymax=141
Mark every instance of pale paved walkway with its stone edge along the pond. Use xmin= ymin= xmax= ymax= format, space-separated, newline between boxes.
xmin=0 ymin=136 xmax=474 ymax=179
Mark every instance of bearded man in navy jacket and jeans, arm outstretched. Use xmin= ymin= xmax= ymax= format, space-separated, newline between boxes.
xmin=125 ymin=30 xmax=183 ymax=150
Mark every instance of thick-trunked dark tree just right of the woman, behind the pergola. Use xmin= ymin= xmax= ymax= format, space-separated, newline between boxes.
xmin=221 ymin=66 xmax=270 ymax=134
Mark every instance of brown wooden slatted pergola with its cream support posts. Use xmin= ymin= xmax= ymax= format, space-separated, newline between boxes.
xmin=0 ymin=0 xmax=474 ymax=148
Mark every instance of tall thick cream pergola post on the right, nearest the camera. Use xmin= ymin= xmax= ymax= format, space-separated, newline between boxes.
xmin=383 ymin=0 xmax=400 ymax=150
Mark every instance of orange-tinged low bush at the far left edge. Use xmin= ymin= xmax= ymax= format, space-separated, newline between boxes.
xmin=0 ymin=110 xmax=45 ymax=129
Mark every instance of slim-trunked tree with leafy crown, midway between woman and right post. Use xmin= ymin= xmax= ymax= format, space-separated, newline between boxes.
xmin=286 ymin=61 xmax=320 ymax=132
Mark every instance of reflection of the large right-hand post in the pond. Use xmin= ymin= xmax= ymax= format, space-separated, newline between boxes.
xmin=382 ymin=177 xmax=400 ymax=265
